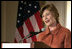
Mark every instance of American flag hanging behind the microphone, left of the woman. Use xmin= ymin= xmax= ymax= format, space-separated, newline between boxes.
xmin=14 ymin=1 xmax=43 ymax=43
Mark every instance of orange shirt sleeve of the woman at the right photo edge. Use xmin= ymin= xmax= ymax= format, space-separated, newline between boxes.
xmin=64 ymin=31 xmax=71 ymax=48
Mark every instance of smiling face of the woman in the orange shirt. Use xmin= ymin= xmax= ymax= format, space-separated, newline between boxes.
xmin=42 ymin=9 xmax=56 ymax=26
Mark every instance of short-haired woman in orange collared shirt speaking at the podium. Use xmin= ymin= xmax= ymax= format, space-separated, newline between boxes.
xmin=37 ymin=4 xmax=71 ymax=48
